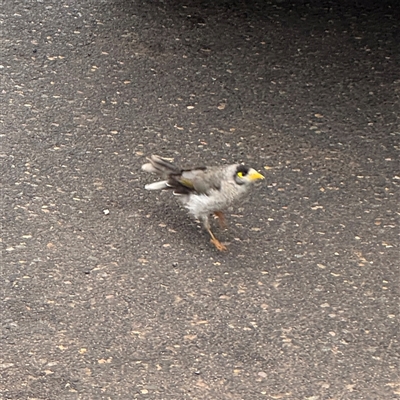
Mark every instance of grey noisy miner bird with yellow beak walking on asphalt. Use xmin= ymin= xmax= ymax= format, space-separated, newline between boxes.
xmin=142 ymin=155 xmax=264 ymax=251
